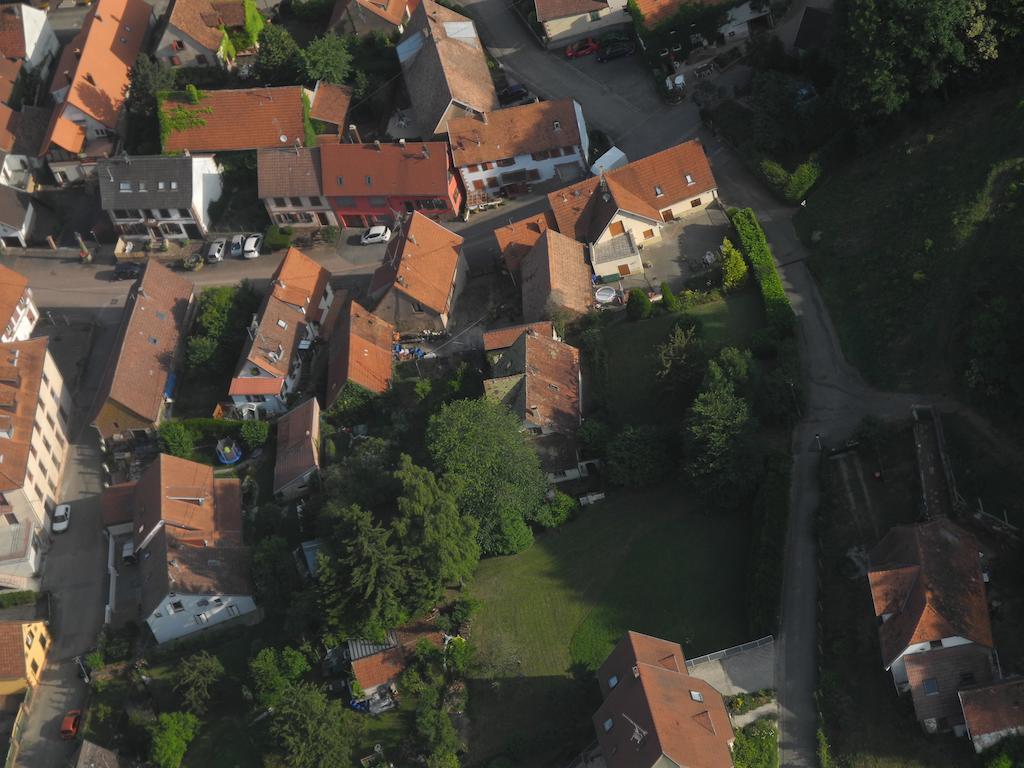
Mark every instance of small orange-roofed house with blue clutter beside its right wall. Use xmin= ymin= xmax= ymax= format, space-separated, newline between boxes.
xmin=326 ymin=301 xmax=395 ymax=409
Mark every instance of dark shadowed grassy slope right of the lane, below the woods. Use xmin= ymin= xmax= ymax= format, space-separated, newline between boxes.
xmin=797 ymin=87 xmax=1024 ymax=397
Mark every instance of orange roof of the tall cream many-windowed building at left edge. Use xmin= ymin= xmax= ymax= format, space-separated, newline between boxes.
xmin=0 ymin=337 xmax=46 ymax=492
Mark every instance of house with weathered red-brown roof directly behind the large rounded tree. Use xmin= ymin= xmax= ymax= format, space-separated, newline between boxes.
xmin=483 ymin=323 xmax=588 ymax=482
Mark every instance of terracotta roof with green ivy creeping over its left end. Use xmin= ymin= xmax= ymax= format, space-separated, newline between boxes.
xmin=162 ymin=85 xmax=305 ymax=152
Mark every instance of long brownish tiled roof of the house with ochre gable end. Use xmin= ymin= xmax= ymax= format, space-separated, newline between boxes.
xmin=95 ymin=260 xmax=193 ymax=434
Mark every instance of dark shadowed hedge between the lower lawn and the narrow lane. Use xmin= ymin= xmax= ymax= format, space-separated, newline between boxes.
xmin=746 ymin=452 xmax=793 ymax=636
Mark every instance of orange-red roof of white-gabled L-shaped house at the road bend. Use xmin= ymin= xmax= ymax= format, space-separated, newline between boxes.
xmin=548 ymin=139 xmax=718 ymax=243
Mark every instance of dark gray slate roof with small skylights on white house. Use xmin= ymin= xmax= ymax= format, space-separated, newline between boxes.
xmin=96 ymin=155 xmax=193 ymax=211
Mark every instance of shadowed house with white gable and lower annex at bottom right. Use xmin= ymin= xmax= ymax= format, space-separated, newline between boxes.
xmin=867 ymin=518 xmax=992 ymax=735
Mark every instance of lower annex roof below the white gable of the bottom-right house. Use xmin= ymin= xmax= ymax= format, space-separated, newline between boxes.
xmin=904 ymin=643 xmax=992 ymax=726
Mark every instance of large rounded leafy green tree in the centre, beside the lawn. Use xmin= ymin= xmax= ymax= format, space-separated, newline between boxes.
xmin=427 ymin=399 xmax=547 ymax=554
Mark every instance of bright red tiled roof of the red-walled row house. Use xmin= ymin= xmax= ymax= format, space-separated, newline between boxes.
xmin=321 ymin=141 xmax=451 ymax=200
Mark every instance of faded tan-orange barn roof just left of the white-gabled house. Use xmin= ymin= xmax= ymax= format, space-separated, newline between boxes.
xmin=521 ymin=229 xmax=593 ymax=323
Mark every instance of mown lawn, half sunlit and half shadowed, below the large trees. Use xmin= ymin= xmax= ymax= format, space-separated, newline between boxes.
xmin=470 ymin=485 xmax=749 ymax=766
